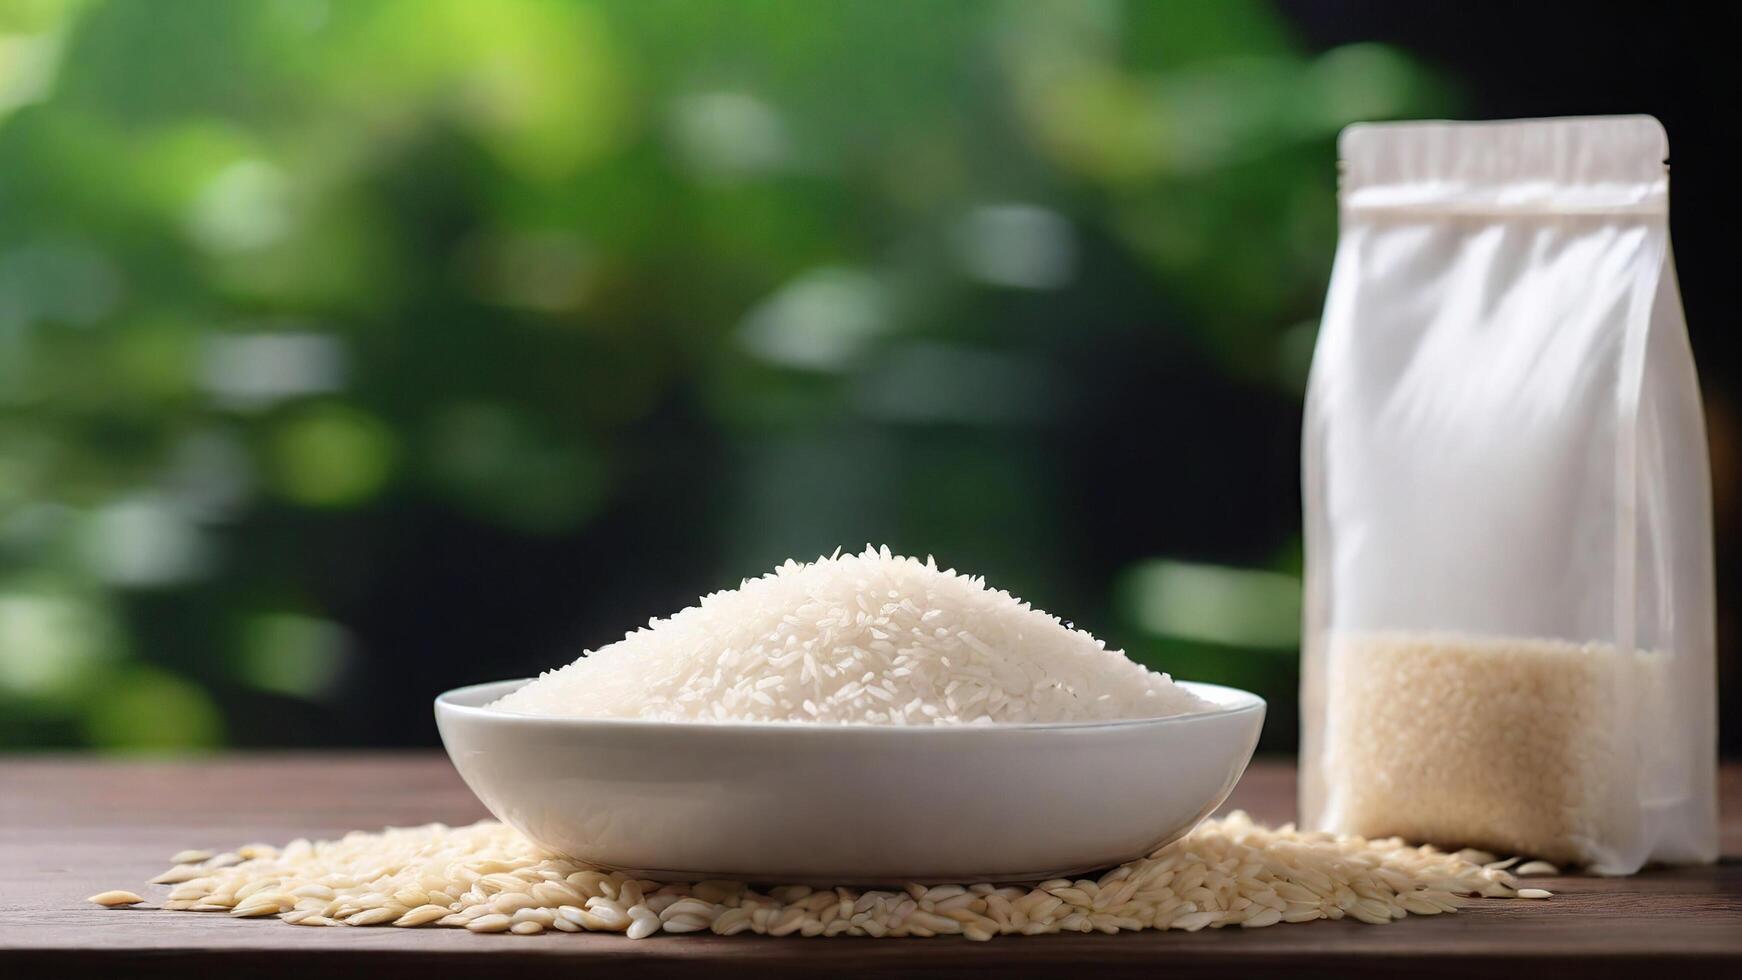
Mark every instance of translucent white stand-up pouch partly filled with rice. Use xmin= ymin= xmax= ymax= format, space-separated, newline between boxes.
xmin=1301 ymin=117 xmax=1718 ymax=874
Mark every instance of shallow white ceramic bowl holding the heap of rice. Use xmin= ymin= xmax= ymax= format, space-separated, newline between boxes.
xmin=436 ymin=681 xmax=1265 ymax=884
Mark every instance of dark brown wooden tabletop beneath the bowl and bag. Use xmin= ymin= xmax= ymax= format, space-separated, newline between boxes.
xmin=0 ymin=754 xmax=1742 ymax=980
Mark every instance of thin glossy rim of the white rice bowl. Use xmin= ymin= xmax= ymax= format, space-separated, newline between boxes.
xmin=436 ymin=677 xmax=1268 ymax=738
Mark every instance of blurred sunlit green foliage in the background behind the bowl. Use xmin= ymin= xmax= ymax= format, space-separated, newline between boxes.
xmin=0 ymin=0 xmax=1444 ymax=747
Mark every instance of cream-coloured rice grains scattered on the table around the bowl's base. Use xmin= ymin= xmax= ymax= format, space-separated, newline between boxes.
xmin=105 ymin=813 xmax=1549 ymax=942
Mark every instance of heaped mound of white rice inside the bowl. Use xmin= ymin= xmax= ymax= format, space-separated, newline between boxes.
xmin=493 ymin=547 xmax=1209 ymax=724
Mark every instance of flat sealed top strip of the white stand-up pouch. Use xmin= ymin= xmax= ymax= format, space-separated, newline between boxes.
xmin=1338 ymin=115 xmax=1669 ymax=214
